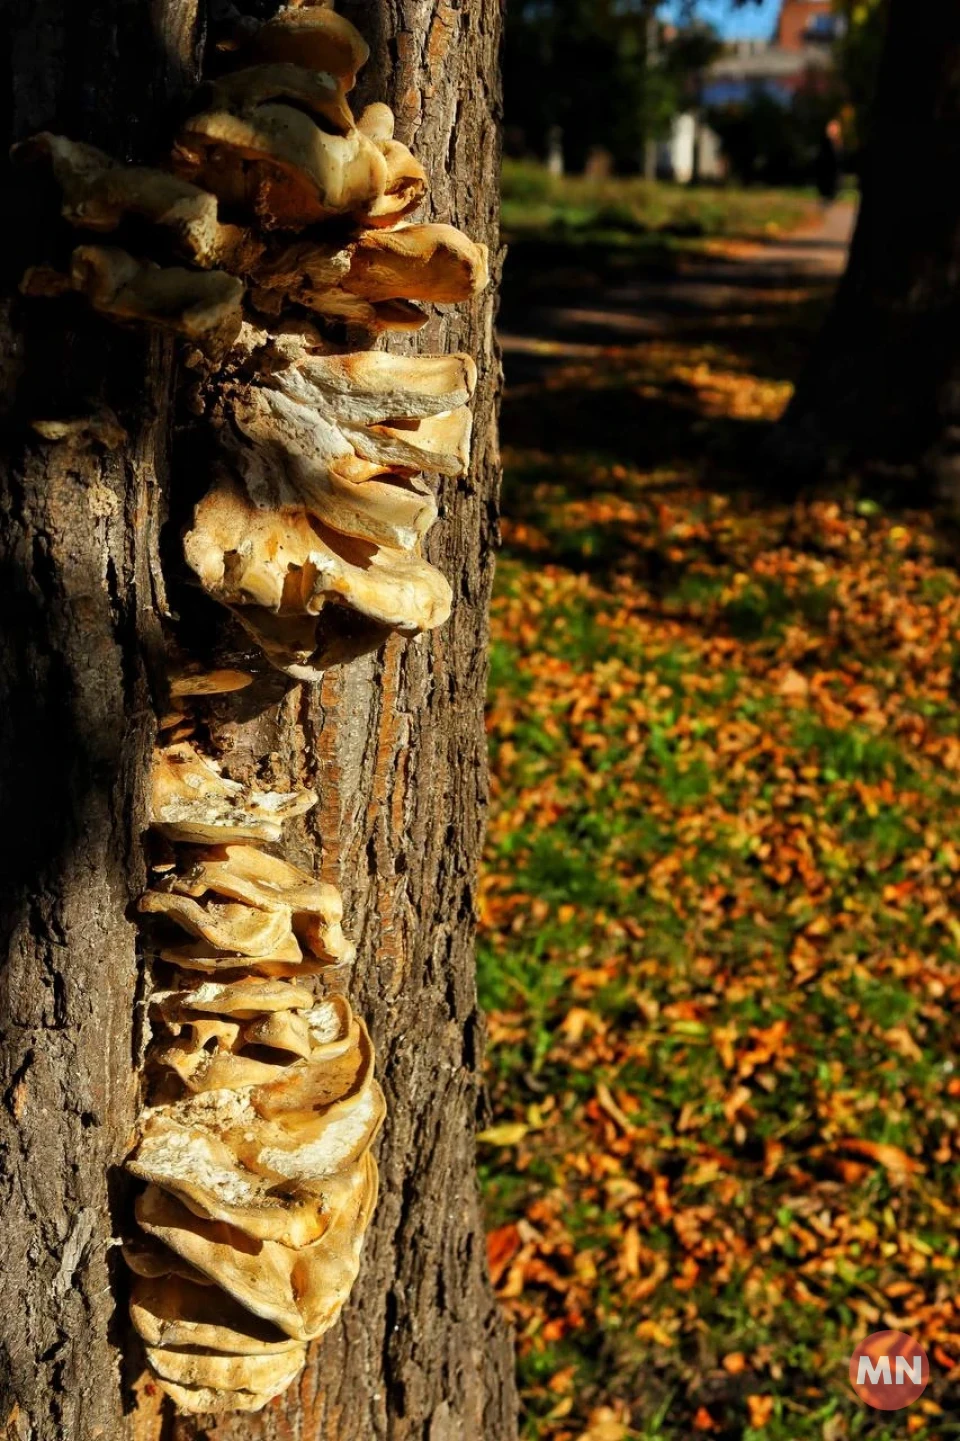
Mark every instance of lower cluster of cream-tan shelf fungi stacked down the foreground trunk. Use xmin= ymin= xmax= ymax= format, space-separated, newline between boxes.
xmin=125 ymin=714 xmax=383 ymax=1412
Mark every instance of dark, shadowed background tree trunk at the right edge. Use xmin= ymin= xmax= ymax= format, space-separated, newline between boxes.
xmin=777 ymin=0 xmax=960 ymax=491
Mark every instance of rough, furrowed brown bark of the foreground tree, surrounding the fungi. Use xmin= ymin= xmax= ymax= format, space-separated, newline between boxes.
xmin=0 ymin=0 xmax=516 ymax=1441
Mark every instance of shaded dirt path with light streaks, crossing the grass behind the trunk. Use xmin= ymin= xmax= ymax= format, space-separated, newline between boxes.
xmin=500 ymin=202 xmax=855 ymax=366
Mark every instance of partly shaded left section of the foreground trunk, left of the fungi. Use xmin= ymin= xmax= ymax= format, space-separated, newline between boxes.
xmin=0 ymin=0 xmax=192 ymax=1441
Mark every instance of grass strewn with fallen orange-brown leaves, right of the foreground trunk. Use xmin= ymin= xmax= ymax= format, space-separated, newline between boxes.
xmin=480 ymin=221 xmax=960 ymax=1441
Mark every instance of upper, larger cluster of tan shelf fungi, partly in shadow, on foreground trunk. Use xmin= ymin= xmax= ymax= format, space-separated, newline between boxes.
xmin=17 ymin=4 xmax=487 ymax=680
